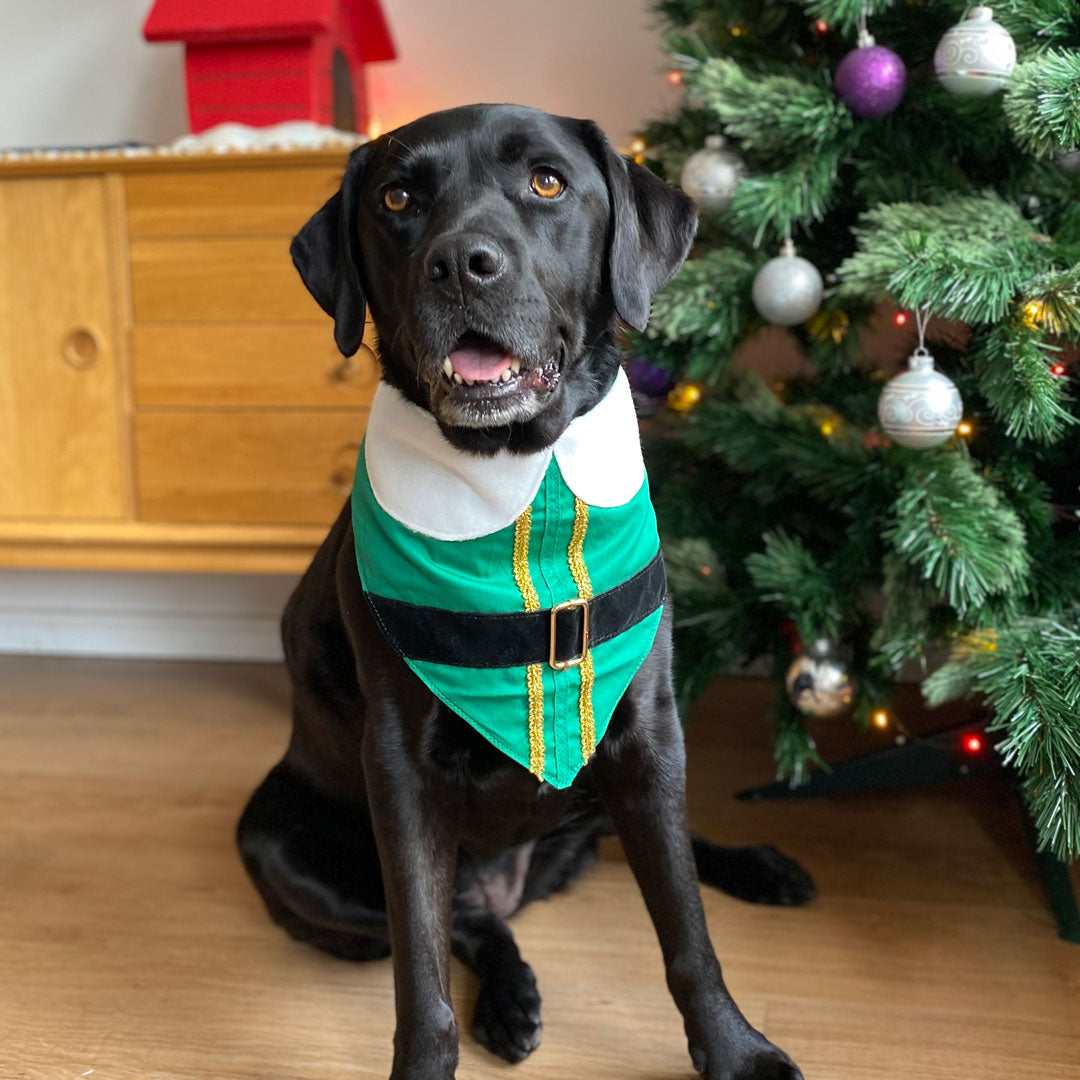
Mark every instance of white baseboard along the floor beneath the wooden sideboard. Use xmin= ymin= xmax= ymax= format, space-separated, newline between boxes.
xmin=0 ymin=570 xmax=296 ymax=662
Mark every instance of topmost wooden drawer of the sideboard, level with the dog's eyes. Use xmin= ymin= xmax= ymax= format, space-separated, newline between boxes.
xmin=124 ymin=166 xmax=346 ymax=240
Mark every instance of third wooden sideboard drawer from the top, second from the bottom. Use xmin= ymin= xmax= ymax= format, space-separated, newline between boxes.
xmin=132 ymin=319 xmax=379 ymax=408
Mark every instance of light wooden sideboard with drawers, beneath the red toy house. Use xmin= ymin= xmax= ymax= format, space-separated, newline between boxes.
xmin=0 ymin=149 xmax=378 ymax=572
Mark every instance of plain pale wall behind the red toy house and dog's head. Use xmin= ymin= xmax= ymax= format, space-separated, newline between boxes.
xmin=0 ymin=0 xmax=672 ymax=147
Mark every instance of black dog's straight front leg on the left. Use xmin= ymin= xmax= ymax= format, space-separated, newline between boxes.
xmin=363 ymin=705 xmax=462 ymax=1080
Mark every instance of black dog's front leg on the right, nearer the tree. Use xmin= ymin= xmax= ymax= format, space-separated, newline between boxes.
xmin=593 ymin=667 xmax=802 ymax=1080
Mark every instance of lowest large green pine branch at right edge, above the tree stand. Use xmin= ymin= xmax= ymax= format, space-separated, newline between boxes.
xmin=923 ymin=613 xmax=1080 ymax=859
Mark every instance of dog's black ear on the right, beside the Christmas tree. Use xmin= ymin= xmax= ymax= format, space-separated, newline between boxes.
xmin=582 ymin=120 xmax=698 ymax=330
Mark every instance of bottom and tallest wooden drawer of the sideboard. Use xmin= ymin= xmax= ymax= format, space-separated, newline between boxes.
xmin=135 ymin=409 xmax=367 ymax=525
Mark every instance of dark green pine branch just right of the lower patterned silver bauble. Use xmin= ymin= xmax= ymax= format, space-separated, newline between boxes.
xmin=973 ymin=323 xmax=1076 ymax=443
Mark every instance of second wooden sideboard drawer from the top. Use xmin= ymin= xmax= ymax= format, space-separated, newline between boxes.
xmin=131 ymin=237 xmax=326 ymax=323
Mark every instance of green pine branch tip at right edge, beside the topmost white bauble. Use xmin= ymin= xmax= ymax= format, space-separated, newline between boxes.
xmin=1002 ymin=50 xmax=1080 ymax=158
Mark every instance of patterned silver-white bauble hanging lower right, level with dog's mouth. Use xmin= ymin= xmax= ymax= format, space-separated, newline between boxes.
xmin=878 ymin=348 xmax=963 ymax=450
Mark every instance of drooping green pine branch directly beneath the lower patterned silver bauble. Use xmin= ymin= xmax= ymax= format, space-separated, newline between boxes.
xmin=885 ymin=450 xmax=1029 ymax=615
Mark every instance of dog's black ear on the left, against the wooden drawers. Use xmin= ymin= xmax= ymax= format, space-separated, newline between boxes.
xmin=288 ymin=144 xmax=370 ymax=356
